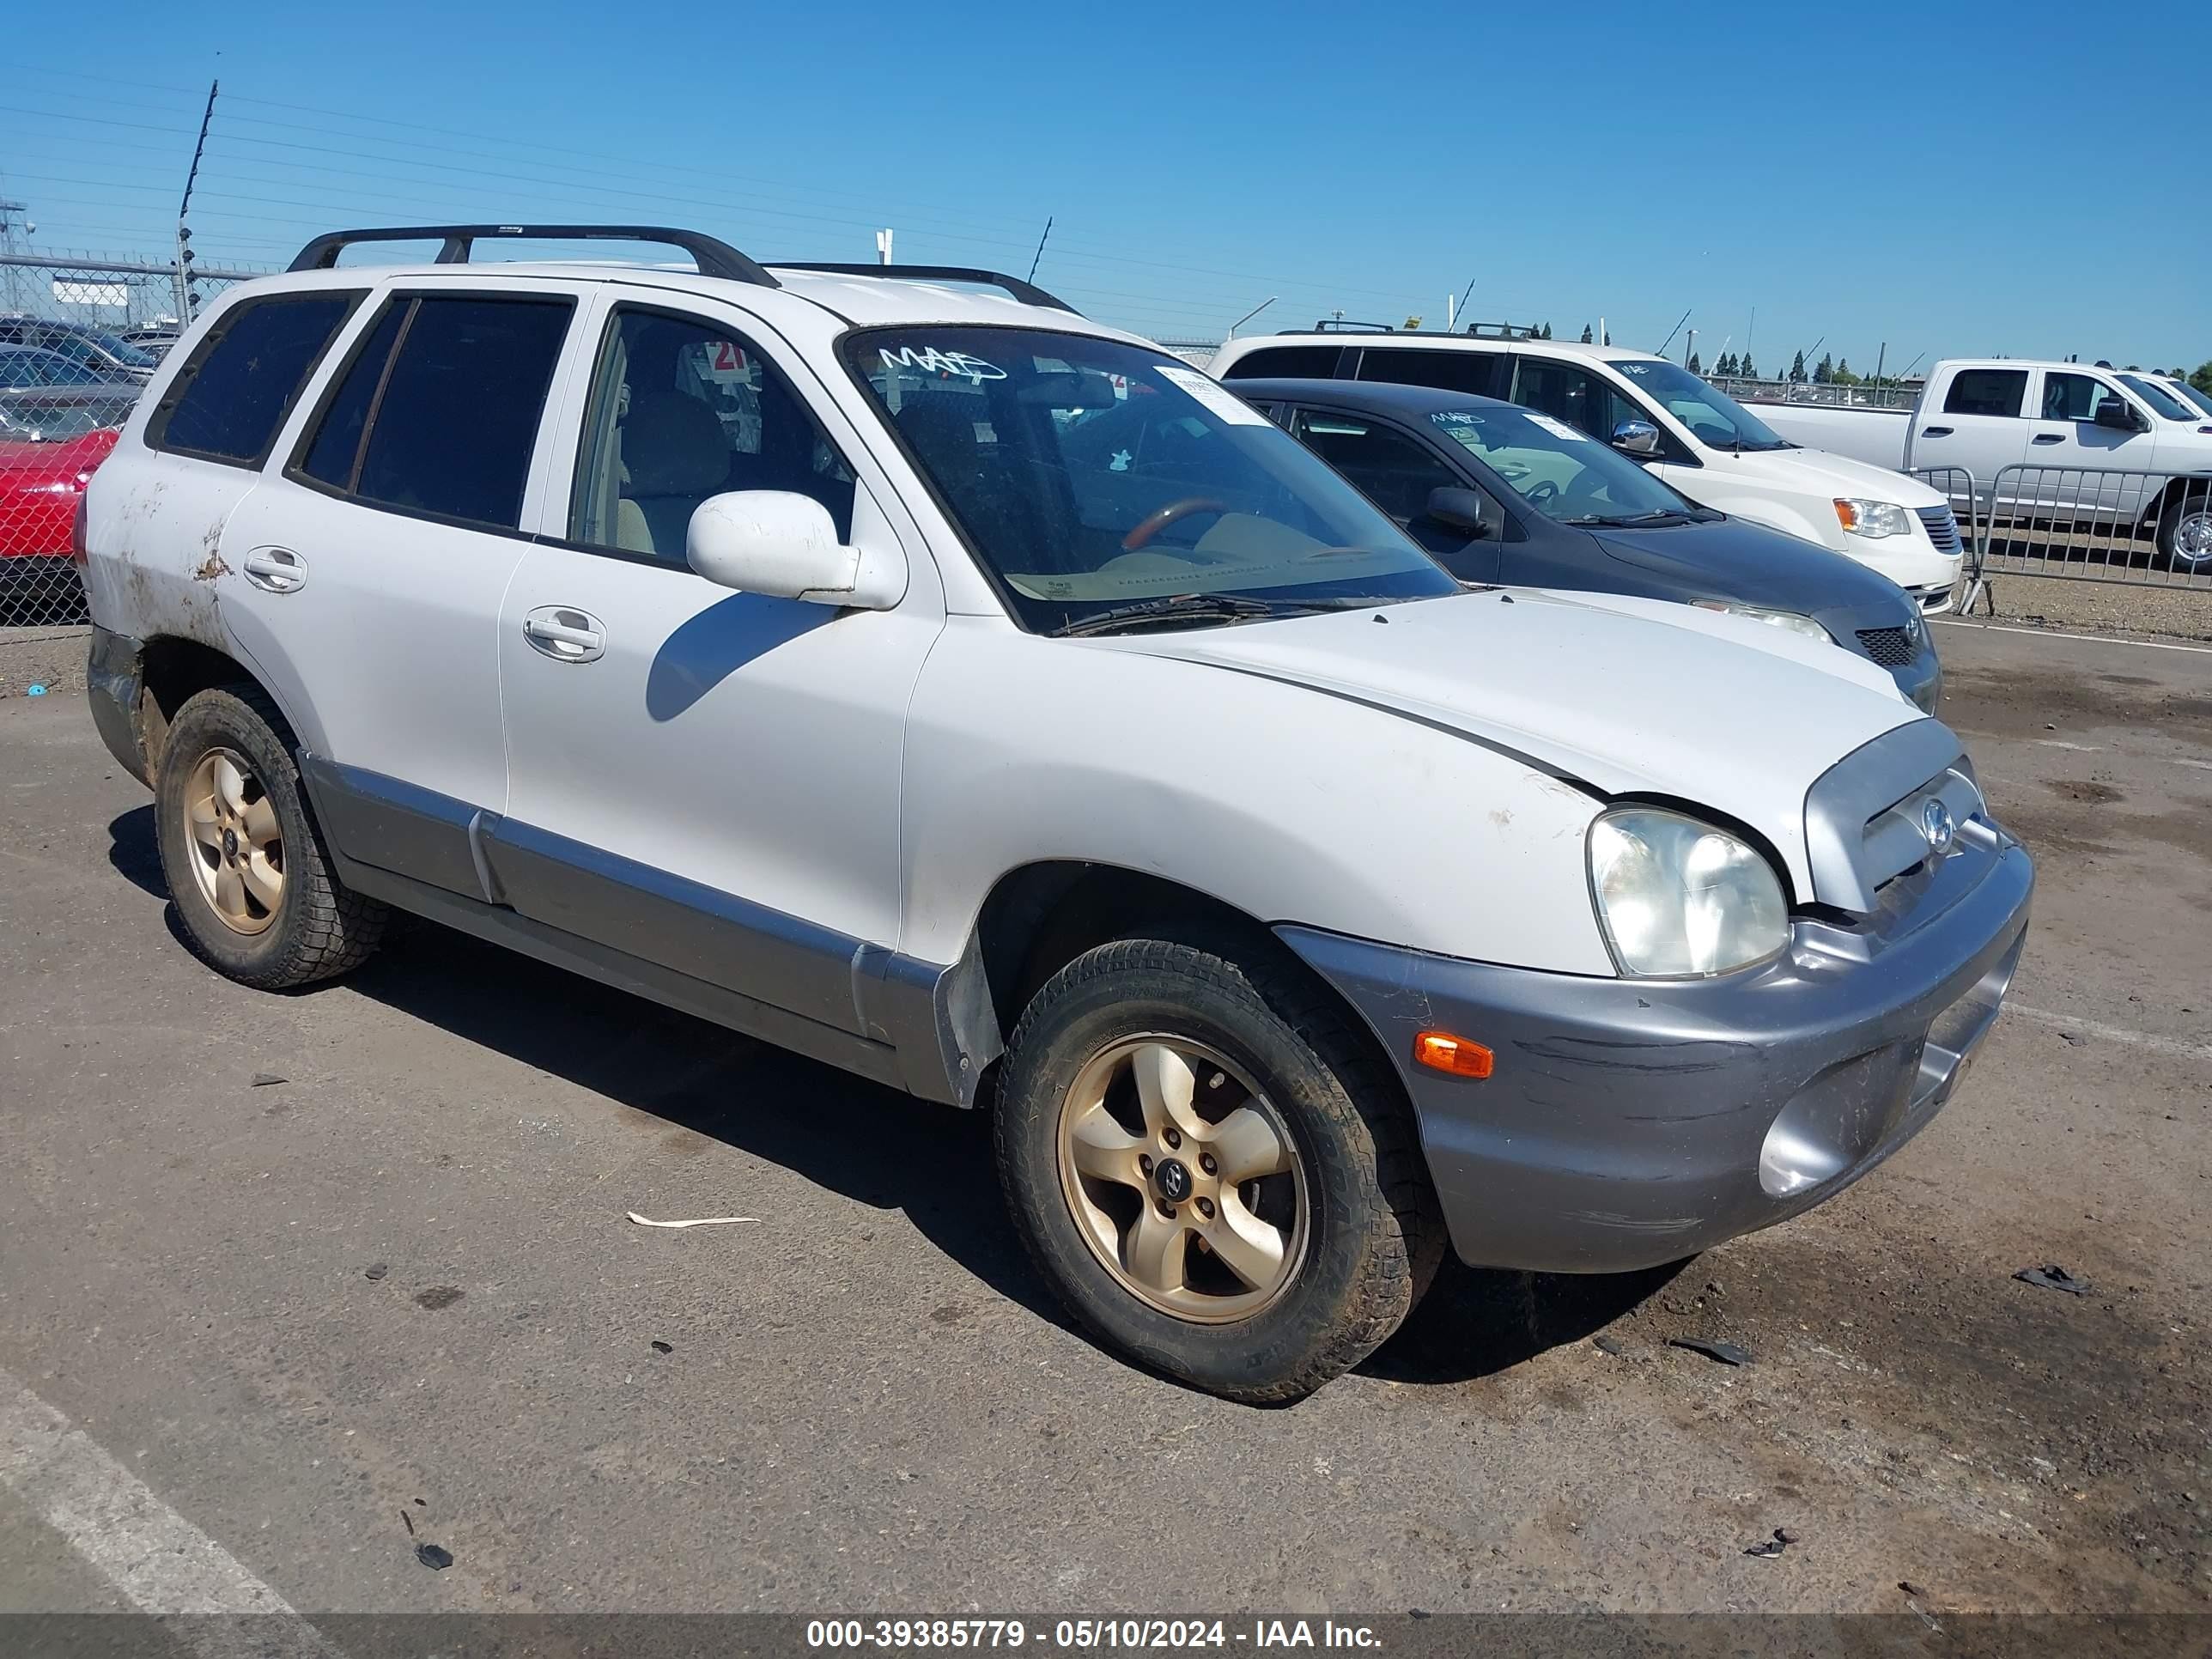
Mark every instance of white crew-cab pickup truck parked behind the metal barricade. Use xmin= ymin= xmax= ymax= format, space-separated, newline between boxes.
xmin=1756 ymin=358 xmax=2212 ymax=571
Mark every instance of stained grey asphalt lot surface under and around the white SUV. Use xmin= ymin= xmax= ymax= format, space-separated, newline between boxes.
xmin=0 ymin=626 xmax=2212 ymax=1631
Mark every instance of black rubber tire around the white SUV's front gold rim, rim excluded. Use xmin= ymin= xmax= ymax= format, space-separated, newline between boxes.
xmin=998 ymin=938 xmax=1444 ymax=1405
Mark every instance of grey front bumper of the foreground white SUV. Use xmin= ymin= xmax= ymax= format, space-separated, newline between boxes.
xmin=1279 ymin=836 xmax=2035 ymax=1272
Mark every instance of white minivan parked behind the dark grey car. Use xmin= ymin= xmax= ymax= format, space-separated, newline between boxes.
xmin=1207 ymin=327 xmax=1962 ymax=615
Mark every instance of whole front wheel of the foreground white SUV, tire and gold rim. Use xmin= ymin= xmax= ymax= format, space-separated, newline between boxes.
xmin=998 ymin=940 xmax=1444 ymax=1402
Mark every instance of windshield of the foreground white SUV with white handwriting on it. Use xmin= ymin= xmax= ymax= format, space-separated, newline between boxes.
xmin=845 ymin=327 xmax=1458 ymax=633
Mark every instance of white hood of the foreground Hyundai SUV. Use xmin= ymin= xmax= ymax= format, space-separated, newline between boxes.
xmin=1115 ymin=588 xmax=1924 ymax=894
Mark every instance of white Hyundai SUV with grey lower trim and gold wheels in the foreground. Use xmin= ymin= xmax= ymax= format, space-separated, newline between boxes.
xmin=82 ymin=226 xmax=2031 ymax=1401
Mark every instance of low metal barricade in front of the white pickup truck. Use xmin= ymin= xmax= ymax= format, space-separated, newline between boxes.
xmin=1962 ymin=465 xmax=2212 ymax=608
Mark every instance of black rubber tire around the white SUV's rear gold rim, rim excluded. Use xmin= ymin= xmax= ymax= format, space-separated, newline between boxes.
xmin=155 ymin=684 xmax=387 ymax=991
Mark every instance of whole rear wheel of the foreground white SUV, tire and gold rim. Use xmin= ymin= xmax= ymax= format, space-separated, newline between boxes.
xmin=155 ymin=686 xmax=385 ymax=991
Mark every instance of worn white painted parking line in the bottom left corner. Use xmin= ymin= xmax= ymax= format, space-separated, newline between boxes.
xmin=0 ymin=1371 xmax=338 ymax=1659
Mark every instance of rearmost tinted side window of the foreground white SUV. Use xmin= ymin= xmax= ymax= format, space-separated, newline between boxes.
xmin=146 ymin=289 xmax=361 ymax=467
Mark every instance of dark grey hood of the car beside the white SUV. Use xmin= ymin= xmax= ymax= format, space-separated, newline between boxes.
xmin=1583 ymin=518 xmax=1916 ymax=629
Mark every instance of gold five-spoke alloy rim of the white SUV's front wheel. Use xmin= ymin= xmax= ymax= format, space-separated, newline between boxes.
xmin=1060 ymin=1036 xmax=1310 ymax=1325
